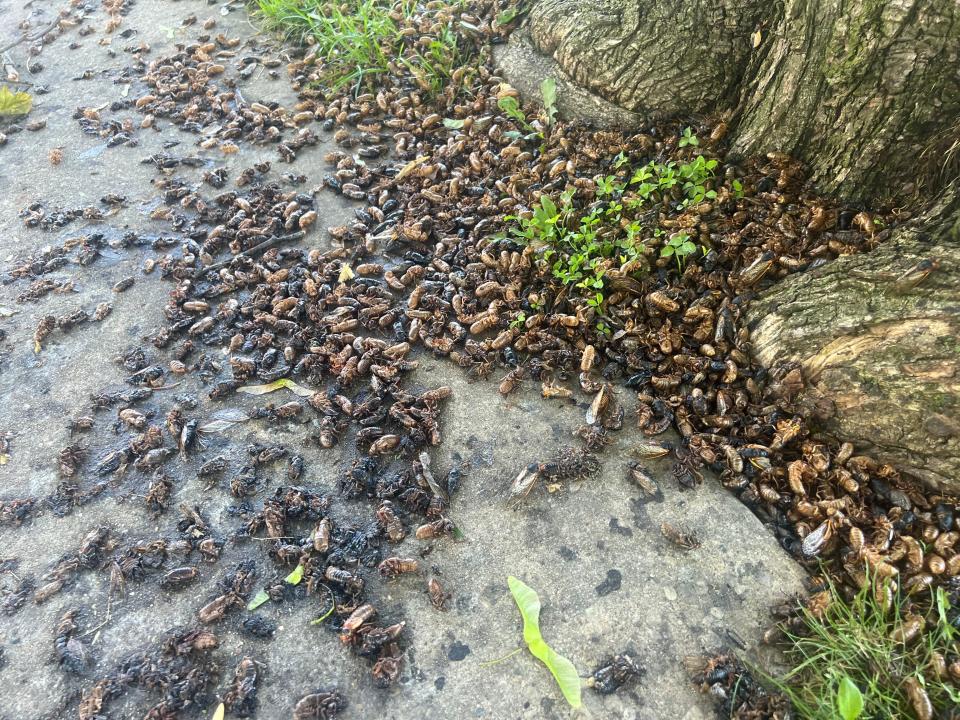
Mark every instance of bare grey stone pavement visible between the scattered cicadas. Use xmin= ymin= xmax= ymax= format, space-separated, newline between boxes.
xmin=0 ymin=0 xmax=803 ymax=720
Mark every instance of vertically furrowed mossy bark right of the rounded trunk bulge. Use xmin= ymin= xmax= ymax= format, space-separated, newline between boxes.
xmin=733 ymin=0 xmax=960 ymax=201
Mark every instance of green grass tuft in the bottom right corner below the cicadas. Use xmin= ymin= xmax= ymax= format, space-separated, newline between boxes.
xmin=768 ymin=581 xmax=960 ymax=720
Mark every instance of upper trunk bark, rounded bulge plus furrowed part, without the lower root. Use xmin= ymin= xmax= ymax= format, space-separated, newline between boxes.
xmin=529 ymin=0 xmax=960 ymax=201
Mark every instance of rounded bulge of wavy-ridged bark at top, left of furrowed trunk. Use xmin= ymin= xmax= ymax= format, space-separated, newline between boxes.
xmin=530 ymin=0 xmax=770 ymax=117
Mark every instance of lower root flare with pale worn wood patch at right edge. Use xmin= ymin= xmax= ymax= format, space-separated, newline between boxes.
xmin=748 ymin=188 xmax=960 ymax=493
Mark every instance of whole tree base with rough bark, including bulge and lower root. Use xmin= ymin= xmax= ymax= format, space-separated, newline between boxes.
xmin=500 ymin=0 xmax=960 ymax=492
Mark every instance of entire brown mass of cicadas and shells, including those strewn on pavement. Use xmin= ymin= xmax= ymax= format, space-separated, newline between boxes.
xmin=0 ymin=2 xmax=960 ymax=717
